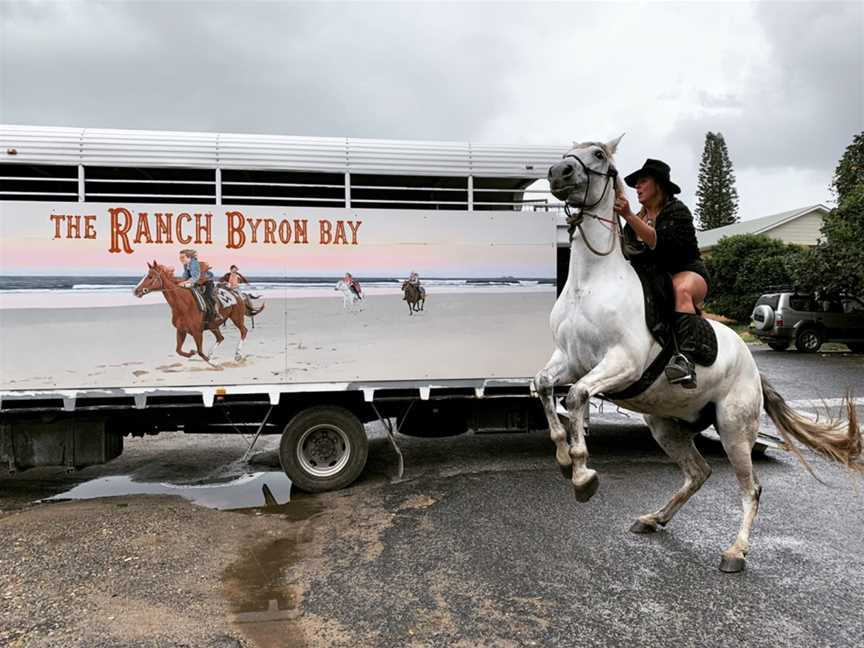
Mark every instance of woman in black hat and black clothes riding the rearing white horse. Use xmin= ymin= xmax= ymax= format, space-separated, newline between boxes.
xmin=615 ymin=158 xmax=710 ymax=388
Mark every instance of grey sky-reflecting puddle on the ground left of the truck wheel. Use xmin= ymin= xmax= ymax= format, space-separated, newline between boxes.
xmin=41 ymin=471 xmax=294 ymax=513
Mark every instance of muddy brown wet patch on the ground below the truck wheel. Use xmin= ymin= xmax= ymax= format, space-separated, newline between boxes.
xmin=223 ymin=497 xmax=324 ymax=648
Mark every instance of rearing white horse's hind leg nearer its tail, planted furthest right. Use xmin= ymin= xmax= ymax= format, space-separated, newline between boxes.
xmin=717 ymin=407 xmax=762 ymax=572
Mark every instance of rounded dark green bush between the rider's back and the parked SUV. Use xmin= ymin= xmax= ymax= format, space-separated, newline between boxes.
xmin=705 ymin=234 xmax=807 ymax=322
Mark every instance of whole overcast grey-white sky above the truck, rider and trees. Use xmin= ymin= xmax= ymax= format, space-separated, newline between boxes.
xmin=0 ymin=0 xmax=864 ymax=219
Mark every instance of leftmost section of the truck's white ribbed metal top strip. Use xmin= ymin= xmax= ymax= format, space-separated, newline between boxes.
xmin=0 ymin=124 xmax=83 ymax=164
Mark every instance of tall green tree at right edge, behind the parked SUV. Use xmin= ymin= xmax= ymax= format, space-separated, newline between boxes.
xmin=793 ymin=131 xmax=864 ymax=295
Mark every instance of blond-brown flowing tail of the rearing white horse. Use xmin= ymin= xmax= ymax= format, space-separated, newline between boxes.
xmin=760 ymin=374 xmax=864 ymax=477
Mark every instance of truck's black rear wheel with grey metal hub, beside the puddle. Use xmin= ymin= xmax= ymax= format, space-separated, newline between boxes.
xmin=279 ymin=405 xmax=369 ymax=493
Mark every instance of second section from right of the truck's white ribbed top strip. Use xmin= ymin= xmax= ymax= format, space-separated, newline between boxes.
xmin=348 ymin=139 xmax=471 ymax=177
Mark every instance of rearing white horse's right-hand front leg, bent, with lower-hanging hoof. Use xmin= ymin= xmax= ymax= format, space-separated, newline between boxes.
xmin=566 ymin=352 xmax=639 ymax=502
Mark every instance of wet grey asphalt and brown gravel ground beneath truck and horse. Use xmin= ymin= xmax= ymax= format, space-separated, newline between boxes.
xmin=0 ymin=350 xmax=864 ymax=648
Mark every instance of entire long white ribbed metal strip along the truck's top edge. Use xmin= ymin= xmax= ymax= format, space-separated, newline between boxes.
xmin=0 ymin=126 xmax=569 ymax=178
